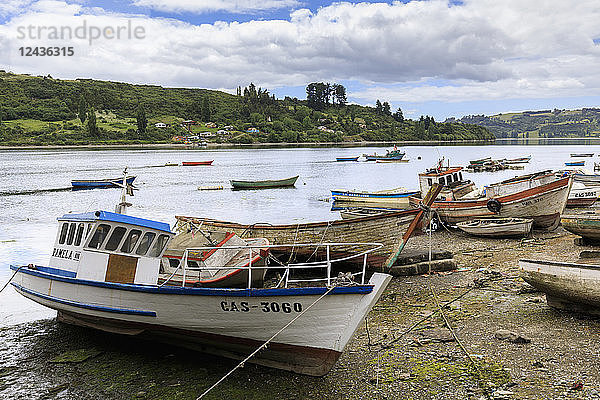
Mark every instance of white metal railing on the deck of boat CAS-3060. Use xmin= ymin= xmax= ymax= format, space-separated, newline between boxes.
xmin=160 ymin=243 xmax=383 ymax=289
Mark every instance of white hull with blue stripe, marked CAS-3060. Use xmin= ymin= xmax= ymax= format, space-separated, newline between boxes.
xmin=11 ymin=267 xmax=391 ymax=376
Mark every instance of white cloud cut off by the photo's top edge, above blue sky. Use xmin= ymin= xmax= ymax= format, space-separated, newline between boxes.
xmin=133 ymin=0 xmax=299 ymax=13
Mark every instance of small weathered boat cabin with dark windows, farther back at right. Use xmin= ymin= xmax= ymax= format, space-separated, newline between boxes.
xmin=419 ymin=167 xmax=475 ymax=200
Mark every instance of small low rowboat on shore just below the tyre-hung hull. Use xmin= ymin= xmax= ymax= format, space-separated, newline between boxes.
xmin=456 ymin=218 xmax=533 ymax=237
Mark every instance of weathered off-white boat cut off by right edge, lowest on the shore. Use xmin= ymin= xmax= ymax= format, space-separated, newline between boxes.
xmin=519 ymin=260 xmax=600 ymax=315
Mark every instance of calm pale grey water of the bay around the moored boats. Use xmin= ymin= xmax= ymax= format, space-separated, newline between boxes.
xmin=0 ymin=145 xmax=600 ymax=326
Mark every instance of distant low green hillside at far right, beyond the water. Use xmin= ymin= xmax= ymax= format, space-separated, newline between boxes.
xmin=449 ymin=108 xmax=600 ymax=138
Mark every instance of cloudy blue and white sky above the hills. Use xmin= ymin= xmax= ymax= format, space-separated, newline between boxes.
xmin=0 ymin=0 xmax=600 ymax=121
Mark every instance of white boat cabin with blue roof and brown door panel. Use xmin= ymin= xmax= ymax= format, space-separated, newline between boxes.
xmin=49 ymin=211 xmax=175 ymax=285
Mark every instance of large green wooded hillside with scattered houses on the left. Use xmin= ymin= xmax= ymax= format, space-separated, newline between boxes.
xmin=0 ymin=71 xmax=493 ymax=145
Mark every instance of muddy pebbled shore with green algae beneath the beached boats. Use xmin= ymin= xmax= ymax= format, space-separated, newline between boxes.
xmin=0 ymin=228 xmax=600 ymax=400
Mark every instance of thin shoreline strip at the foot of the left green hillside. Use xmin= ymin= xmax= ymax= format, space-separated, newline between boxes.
xmin=0 ymin=139 xmax=495 ymax=150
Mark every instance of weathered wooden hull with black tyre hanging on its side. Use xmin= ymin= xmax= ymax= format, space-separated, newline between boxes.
xmin=414 ymin=177 xmax=572 ymax=229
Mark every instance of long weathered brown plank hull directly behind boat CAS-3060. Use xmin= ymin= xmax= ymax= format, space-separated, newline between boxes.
xmin=175 ymin=209 xmax=419 ymax=266
